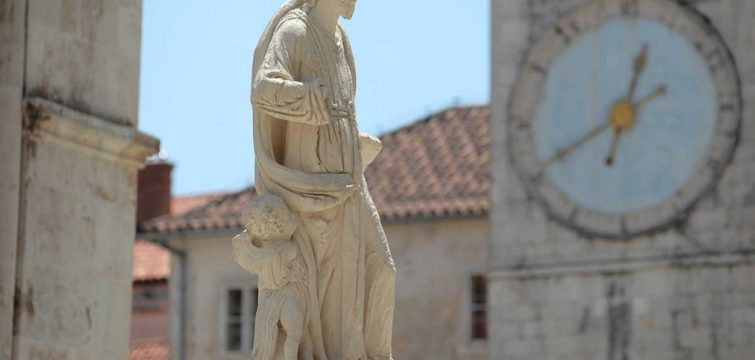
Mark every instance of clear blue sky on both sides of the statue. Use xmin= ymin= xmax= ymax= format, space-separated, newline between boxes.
xmin=139 ymin=0 xmax=490 ymax=195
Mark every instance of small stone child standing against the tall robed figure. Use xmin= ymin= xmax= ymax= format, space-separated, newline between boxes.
xmin=232 ymin=194 xmax=308 ymax=360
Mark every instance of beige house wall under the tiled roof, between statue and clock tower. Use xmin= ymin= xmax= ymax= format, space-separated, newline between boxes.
xmin=385 ymin=218 xmax=490 ymax=360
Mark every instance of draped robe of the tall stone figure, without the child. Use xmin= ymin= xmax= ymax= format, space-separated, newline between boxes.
xmin=252 ymin=2 xmax=395 ymax=360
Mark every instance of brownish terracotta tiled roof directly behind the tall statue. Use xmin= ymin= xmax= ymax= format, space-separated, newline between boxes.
xmin=139 ymin=106 xmax=490 ymax=234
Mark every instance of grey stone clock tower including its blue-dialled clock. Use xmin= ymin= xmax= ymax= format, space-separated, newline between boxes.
xmin=489 ymin=0 xmax=755 ymax=360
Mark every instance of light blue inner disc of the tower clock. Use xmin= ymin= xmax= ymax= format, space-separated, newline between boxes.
xmin=534 ymin=19 xmax=718 ymax=214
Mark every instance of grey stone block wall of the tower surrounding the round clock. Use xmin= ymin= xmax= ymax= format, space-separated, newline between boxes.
xmin=490 ymin=0 xmax=755 ymax=360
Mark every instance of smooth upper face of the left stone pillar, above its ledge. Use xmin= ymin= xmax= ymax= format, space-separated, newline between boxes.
xmin=24 ymin=0 xmax=142 ymax=126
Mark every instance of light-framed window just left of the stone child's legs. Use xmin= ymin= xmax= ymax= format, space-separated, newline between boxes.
xmin=223 ymin=286 xmax=258 ymax=353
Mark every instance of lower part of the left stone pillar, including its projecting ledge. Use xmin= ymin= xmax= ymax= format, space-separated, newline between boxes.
xmin=14 ymin=99 xmax=157 ymax=359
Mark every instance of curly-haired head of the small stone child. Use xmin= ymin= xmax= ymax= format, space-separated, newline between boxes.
xmin=243 ymin=194 xmax=296 ymax=242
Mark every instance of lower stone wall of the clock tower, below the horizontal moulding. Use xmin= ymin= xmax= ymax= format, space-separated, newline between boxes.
xmin=490 ymin=262 xmax=755 ymax=360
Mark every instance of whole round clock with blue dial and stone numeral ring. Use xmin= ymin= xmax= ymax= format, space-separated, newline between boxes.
xmin=508 ymin=0 xmax=741 ymax=237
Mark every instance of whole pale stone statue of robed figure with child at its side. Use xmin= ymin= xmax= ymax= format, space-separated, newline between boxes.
xmin=233 ymin=0 xmax=396 ymax=360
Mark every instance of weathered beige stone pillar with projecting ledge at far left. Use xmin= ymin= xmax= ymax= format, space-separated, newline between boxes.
xmin=0 ymin=0 xmax=159 ymax=360
